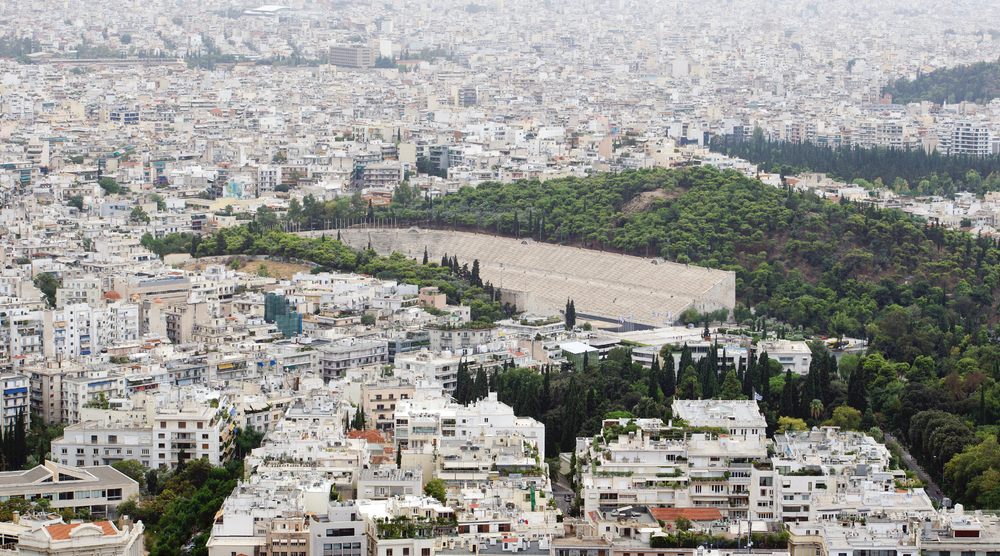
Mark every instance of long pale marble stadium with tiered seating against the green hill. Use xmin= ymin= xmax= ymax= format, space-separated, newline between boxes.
xmin=332 ymin=228 xmax=736 ymax=327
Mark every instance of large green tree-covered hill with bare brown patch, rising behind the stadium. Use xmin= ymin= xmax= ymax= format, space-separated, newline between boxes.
xmin=168 ymin=168 xmax=1000 ymax=356
